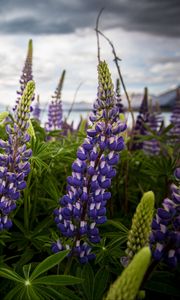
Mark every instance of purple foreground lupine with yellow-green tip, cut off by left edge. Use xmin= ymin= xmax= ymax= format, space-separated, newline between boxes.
xmin=0 ymin=81 xmax=35 ymax=230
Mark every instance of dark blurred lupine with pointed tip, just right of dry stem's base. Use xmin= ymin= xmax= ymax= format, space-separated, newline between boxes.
xmin=131 ymin=87 xmax=149 ymax=150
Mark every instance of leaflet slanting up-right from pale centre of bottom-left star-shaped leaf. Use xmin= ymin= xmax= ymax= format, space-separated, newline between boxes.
xmin=30 ymin=250 xmax=69 ymax=280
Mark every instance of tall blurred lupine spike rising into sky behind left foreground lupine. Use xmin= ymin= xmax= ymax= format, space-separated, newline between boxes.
xmin=13 ymin=40 xmax=34 ymax=111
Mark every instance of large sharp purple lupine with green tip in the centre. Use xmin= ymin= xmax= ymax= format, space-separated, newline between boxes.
xmin=52 ymin=62 xmax=126 ymax=263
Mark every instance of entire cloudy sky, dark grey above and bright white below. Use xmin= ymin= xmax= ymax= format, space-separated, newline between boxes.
xmin=0 ymin=0 xmax=180 ymax=105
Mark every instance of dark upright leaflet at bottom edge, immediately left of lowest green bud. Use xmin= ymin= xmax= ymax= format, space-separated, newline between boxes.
xmin=93 ymin=268 xmax=109 ymax=300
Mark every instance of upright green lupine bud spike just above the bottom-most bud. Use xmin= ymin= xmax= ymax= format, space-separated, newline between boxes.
xmin=126 ymin=191 xmax=154 ymax=261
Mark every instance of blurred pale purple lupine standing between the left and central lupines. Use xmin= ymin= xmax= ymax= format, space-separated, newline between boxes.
xmin=46 ymin=70 xmax=65 ymax=131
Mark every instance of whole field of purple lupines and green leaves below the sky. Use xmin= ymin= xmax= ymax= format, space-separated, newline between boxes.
xmin=0 ymin=40 xmax=180 ymax=300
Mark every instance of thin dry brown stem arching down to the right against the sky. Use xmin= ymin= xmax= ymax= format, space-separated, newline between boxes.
xmin=98 ymin=30 xmax=135 ymax=128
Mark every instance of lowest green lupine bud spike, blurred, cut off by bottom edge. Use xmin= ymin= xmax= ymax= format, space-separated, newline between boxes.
xmin=106 ymin=247 xmax=151 ymax=300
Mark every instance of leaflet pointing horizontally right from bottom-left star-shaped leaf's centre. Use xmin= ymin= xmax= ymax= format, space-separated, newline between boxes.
xmin=33 ymin=275 xmax=83 ymax=285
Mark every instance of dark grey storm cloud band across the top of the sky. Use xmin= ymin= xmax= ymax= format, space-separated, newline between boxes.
xmin=0 ymin=0 xmax=180 ymax=37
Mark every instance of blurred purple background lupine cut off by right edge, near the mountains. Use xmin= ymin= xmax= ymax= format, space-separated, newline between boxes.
xmin=170 ymin=87 xmax=180 ymax=145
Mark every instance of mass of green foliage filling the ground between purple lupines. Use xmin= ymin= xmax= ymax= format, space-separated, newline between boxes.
xmin=0 ymin=41 xmax=180 ymax=300
